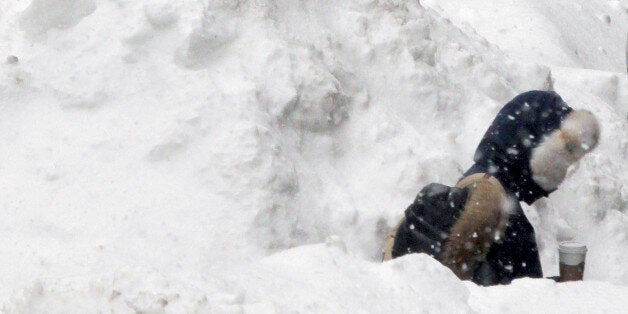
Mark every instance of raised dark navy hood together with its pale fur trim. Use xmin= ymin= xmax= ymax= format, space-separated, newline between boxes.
xmin=465 ymin=91 xmax=600 ymax=204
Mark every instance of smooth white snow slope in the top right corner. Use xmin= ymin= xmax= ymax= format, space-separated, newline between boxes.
xmin=423 ymin=0 xmax=628 ymax=72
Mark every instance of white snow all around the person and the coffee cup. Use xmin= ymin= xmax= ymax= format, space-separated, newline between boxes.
xmin=0 ymin=0 xmax=628 ymax=313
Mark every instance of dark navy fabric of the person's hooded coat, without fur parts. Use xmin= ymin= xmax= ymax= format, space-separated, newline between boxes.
xmin=392 ymin=91 xmax=572 ymax=285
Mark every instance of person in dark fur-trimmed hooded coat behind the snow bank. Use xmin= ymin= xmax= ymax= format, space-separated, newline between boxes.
xmin=384 ymin=91 xmax=600 ymax=285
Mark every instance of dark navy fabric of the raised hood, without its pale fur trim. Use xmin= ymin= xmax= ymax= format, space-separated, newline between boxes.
xmin=465 ymin=91 xmax=573 ymax=204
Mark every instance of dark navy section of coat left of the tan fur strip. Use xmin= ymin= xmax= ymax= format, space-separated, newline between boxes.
xmin=392 ymin=183 xmax=468 ymax=260
